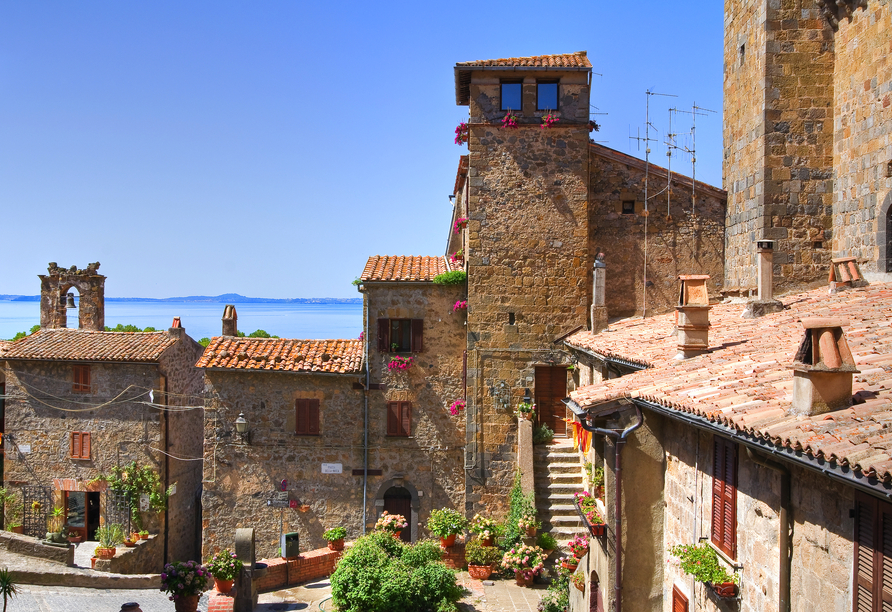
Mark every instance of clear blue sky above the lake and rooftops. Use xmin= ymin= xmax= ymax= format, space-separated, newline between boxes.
xmin=0 ymin=0 xmax=723 ymax=297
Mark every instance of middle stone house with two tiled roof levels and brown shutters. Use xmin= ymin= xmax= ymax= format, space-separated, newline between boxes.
xmin=198 ymin=256 xmax=465 ymax=557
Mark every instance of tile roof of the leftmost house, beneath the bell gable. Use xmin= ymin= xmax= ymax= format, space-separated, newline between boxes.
xmin=2 ymin=328 xmax=177 ymax=363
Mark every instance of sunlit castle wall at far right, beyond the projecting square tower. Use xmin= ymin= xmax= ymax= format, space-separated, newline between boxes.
xmin=833 ymin=0 xmax=892 ymax=272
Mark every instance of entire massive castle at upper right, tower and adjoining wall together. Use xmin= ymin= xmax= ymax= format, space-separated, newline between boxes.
xmin=724 ymin=0 xmax=892 ymax=293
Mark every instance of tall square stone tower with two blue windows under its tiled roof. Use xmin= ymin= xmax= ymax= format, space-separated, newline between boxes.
xmin=450 ymin=52 xmax=592 ymax=513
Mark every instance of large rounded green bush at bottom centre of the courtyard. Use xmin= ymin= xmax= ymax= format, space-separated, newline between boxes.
xmin=331 ymin=532 xmax=462 ymax=612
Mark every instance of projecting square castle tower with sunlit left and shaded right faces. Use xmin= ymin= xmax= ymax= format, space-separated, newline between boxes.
xmin=723 ymin=0 xmax=834 ymax=293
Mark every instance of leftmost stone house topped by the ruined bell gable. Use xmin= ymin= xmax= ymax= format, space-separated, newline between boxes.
xmin=2 ymin=264 xmax=202 ymax=572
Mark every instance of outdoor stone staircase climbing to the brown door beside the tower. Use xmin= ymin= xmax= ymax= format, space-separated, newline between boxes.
xmin=533 ymin=438 xmax=585 ymax=548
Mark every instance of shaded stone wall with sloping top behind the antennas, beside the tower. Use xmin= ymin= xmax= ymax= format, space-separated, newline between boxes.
xmin=589 ymin=145 xmax=725 ymax=317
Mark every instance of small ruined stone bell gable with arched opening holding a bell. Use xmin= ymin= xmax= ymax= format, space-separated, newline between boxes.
xmin=38 ymin=261 xmax=105 ymax=331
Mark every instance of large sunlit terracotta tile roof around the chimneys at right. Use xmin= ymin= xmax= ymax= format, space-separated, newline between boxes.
xmin=567 ymin=284 xmax=892 ymax=482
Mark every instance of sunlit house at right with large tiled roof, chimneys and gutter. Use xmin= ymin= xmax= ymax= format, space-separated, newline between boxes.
xmin=565 ymin=278 xmax=892 ymax=612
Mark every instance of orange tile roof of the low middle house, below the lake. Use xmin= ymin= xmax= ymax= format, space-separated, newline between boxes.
xmin=195 ymin=336 xmax=362 ymax=374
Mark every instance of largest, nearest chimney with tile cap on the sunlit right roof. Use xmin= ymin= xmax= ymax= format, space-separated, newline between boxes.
xmin=790 ymin=318 xmax=858 ymax=416
